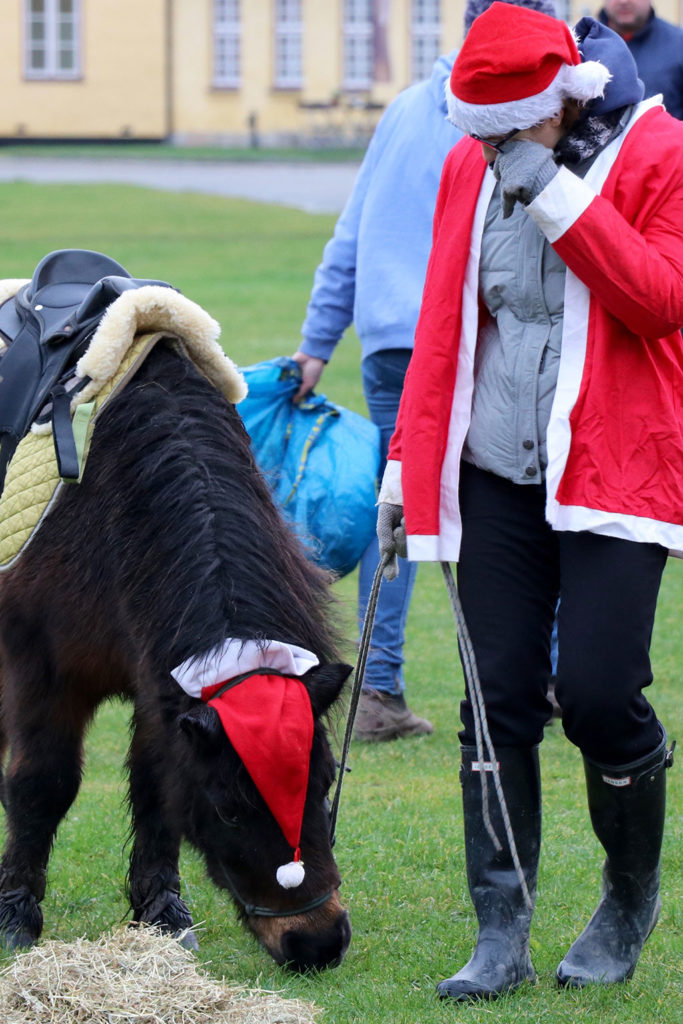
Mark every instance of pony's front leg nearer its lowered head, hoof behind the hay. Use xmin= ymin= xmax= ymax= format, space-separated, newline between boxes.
xmin=128 ymin=716 xmax=199 ymax=949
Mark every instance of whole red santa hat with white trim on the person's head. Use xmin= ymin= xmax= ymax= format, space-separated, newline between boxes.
xmin=445 ymin=0 xmax=611 ymax=138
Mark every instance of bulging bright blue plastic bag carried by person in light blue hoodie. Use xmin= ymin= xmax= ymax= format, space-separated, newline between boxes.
xmin=238 ymin=356 xmax=380 ymax=575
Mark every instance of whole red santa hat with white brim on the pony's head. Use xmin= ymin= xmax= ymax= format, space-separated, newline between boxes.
xmin=171 ymin=638 xmax=318 ymax=889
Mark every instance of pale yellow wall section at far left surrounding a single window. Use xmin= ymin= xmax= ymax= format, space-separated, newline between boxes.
xmin=0 ymin=0 xmax=166 ymax=138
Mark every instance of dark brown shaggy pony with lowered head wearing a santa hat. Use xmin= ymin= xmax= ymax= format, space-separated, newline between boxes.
xmin=0 ymin=260 xmax=350 ymax=970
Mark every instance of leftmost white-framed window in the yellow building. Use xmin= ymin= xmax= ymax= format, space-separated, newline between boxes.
xmin=25 ymin=0 xmax=81 ymax=79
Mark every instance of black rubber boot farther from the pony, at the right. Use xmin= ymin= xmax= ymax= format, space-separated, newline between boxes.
xmin=557 ymin=736 xmax=673 ymax=988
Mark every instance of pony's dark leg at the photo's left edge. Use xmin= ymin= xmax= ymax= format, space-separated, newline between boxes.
xmin=0 ymin=724 xmax=82 ymax=949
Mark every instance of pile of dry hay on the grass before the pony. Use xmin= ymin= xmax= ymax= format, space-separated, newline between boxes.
xmin=0 ymin=928 xmax=317 ymax=1024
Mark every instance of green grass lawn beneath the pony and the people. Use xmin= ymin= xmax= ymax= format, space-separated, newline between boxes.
xmin=0 ymin=184 xmax=683 ymax=1024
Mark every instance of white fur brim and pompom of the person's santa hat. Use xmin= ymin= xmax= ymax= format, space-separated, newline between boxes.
xmin=445 ymin=60 xmax=612 ymax=138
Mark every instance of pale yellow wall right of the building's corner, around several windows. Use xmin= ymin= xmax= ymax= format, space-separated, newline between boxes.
xmin=172 ymin=0 xmax=683 ymax=144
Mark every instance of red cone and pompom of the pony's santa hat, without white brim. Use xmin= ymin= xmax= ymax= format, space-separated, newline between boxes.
xmin=202 ymin=670 xmax=313 ymax=889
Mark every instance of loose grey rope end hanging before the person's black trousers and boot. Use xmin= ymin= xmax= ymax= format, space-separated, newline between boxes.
xmin=441 ymin=562 xmax=533 ymax=910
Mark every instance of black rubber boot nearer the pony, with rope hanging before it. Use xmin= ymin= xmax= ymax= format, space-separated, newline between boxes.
xmin=436 ymin=746 xmax=541 ymax=1002
